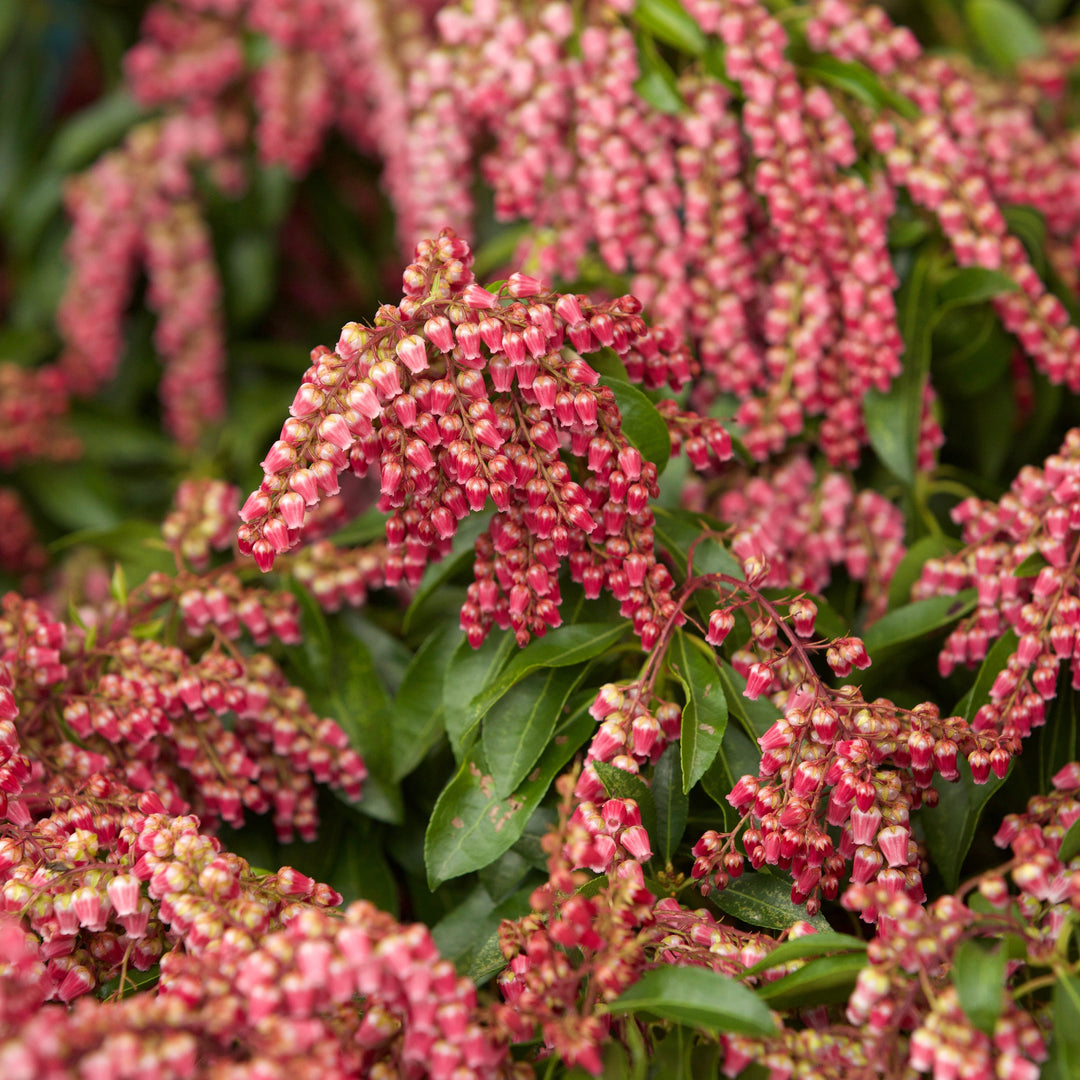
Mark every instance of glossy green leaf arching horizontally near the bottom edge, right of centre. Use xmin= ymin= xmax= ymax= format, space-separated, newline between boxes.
xmin=608 ymin=967 xmax=777 ymax=1035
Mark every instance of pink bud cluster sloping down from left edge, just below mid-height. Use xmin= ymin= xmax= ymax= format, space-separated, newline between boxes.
xmin=0 ymin=594 xmax=367 ymax=841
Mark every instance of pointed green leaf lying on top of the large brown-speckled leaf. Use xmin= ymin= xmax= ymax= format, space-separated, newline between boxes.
xmin=482 ymin=664 xmax=585 ymax=798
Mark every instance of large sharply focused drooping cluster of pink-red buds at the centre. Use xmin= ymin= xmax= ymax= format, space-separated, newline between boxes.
xmin=238 ymin=230 xmax=725 ymax=648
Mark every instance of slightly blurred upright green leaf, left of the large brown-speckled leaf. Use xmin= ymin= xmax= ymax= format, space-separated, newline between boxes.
xmin=390 ymin=622 xmax=461 ymax=780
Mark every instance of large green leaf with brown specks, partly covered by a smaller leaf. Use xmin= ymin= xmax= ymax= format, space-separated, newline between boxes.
xmin=423 ymin=705 xmax=596 ymax=890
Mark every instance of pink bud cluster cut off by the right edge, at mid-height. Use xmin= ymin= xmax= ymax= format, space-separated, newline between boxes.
xmin=913 ymin=429 xmax=1080 ymax=753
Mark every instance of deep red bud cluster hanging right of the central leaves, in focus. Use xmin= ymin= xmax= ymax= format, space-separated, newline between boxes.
xmin=692 ymin=579 xmax=1010 ymax=912
